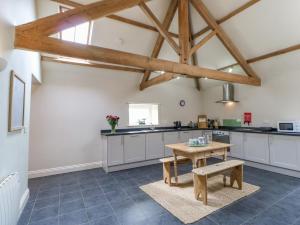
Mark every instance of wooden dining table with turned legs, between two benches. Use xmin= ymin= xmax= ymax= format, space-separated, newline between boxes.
xmin=166 ymin=142 xmax=232 ymax=184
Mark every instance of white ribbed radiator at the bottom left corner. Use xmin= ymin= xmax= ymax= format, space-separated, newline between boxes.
xmin=0 ymin=173 xmax=19 ymax=225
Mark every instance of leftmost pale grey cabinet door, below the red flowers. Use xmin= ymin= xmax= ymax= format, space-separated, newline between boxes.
xmin=107 ymin=136 xmax=124 ymax=166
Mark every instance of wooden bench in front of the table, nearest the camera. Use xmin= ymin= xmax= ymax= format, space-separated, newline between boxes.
xmin=193 ymin=160 xmax=244 ymax=205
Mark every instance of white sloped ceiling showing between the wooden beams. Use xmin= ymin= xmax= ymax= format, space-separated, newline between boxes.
xmin=37 ymin=0 xmax=300 ymax=89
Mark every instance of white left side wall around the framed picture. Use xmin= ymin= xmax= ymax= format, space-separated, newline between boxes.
xmin=0 ymin=0 xmax=41 ymax=214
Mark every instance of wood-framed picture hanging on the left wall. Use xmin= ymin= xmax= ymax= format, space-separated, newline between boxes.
xmin=8 ymin=71 xmax=25 ymax=132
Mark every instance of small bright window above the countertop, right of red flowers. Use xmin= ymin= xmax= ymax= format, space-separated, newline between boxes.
xmin=129 ymin=103 xmax=159 ymax=126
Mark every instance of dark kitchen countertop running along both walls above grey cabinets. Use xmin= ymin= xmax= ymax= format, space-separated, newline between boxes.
xmin=101 ymin=127 xmax=300 ymax=137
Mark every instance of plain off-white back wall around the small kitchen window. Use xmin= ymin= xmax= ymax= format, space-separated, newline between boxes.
xmin=29 ymin=62 xmax=201 ymax=171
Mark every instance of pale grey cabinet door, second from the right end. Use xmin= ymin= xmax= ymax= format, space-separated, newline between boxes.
xmin=243 ymin=133 xmax=270 ymax=164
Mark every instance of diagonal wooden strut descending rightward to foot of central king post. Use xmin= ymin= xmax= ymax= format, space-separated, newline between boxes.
xmin=139 ymin=1 xmax=180 ymax=54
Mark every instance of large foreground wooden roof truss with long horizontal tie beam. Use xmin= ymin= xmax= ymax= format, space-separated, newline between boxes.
xmin=15 ymin=0 xmax=260 ymax=87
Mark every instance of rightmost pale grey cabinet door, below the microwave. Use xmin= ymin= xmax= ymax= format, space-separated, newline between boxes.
xmin=269 ymin=135 xmax=300 ymax=170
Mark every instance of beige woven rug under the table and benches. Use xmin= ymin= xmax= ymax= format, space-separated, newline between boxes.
xmin=140 ymin=174 xmax=260 ymax=224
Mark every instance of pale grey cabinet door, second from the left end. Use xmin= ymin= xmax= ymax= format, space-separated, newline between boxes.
xmin=124 ymin=134 xmax=146 ymax=163
